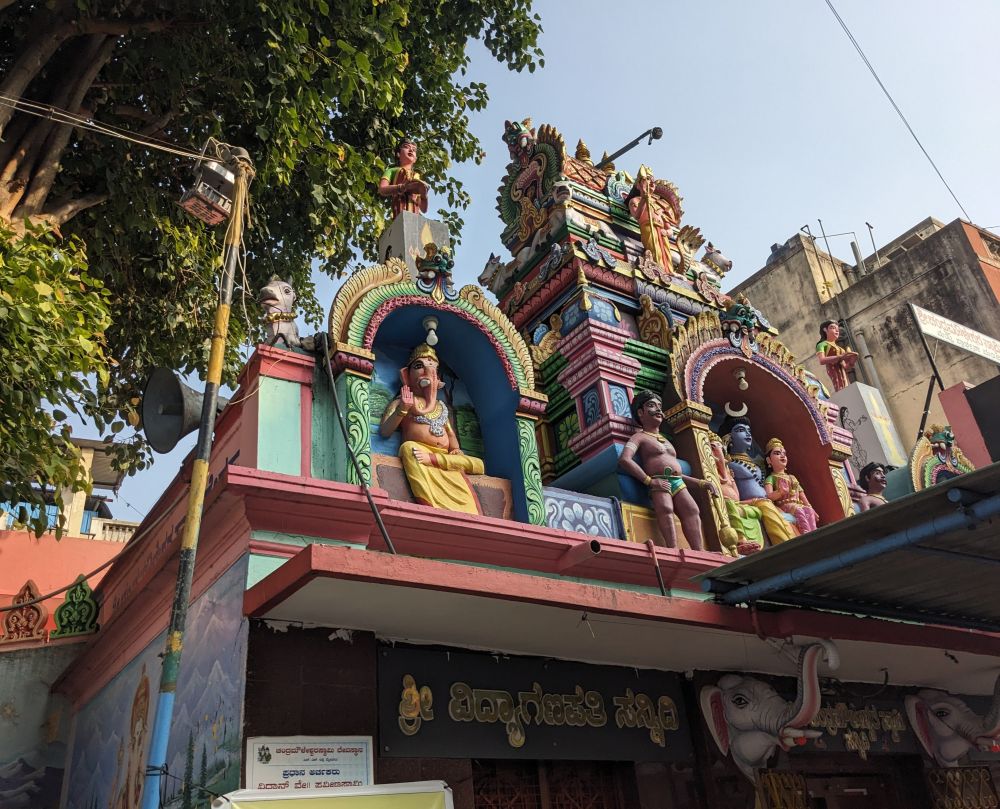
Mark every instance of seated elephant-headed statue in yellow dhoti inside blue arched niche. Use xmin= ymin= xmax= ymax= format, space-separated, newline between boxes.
xmin=379 ymin=343 xmax=484 ymax=514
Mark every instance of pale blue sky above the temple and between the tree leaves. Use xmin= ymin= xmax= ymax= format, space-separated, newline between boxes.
xmin=103 ymin=0 xmax=1000 ymax=519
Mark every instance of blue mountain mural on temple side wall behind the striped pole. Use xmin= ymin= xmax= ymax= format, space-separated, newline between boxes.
xmin=64 ymin=560 xmax=247 ymax=809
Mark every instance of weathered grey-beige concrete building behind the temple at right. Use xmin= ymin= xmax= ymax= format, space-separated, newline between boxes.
xmin=732 ymin=217 xmax=1000 ymax=446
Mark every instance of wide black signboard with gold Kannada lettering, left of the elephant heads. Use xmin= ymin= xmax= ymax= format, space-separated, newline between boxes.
xmin=378 ymin=645 xmax=692 ymax=761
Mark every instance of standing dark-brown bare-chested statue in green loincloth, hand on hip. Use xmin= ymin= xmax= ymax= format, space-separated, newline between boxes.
xmin=618 ymin=390 xmax=717 ymax=551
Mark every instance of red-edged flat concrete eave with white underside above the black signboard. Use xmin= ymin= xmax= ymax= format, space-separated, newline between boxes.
xmin=244 ymin=545 xmax=1000 ymax=693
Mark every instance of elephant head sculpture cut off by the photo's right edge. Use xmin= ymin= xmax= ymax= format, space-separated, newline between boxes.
xmin=903 ymin=676 xmax=1000 ymax=767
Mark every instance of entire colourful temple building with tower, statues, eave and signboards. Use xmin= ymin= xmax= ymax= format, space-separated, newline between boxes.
xmin=7 ymin=121 xmax=1000 ymax=809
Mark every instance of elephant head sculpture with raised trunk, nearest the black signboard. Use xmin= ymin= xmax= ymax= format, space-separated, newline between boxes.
xmin=701 ymin=641 xmax=840 ymax=781
